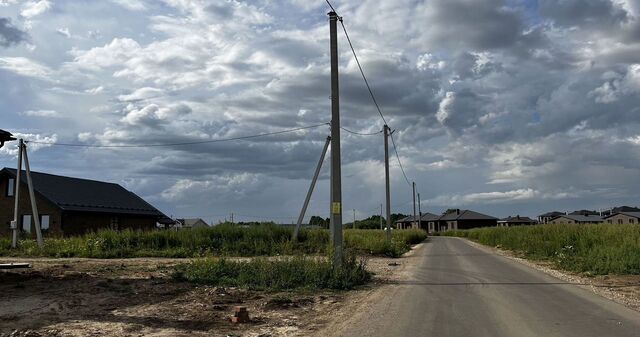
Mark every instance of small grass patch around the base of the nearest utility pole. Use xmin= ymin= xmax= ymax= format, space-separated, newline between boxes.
xmin=173 ymin=256 xmax=371 ymax=290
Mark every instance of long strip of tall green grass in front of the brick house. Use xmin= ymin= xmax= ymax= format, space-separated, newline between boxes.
xmin=0 ymin=224 xmax=426 ymax=258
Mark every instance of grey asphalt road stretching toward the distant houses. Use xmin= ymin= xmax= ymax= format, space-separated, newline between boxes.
xmin=336 ymin=237 xmax=640 ymax=337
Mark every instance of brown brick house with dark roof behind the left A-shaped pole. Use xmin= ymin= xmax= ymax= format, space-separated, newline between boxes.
xmin=0 ymin=168 xmax=167 ymax=236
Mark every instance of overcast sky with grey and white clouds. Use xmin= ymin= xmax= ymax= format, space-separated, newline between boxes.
xmin=0 ymin=0 xmax=640 ymax=222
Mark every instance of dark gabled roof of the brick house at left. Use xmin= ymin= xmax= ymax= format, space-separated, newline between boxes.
xmin=0 ymin=168 xmax=165 ymax=217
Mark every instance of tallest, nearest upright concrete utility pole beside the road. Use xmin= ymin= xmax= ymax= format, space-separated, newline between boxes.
xmin=329 ymin=11 xmax=342 ymax=266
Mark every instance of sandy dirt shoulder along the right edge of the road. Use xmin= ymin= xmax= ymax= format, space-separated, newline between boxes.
xmin=459 ymin=238 xmax=640 ymax=311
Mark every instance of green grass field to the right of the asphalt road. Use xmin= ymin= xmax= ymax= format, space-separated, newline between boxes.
xmin=443 ymin=224 xmax=640 ymax=275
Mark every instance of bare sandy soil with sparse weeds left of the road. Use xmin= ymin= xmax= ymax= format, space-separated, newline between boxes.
xmin=0 ymin=249 xmax=420 ymax=337
